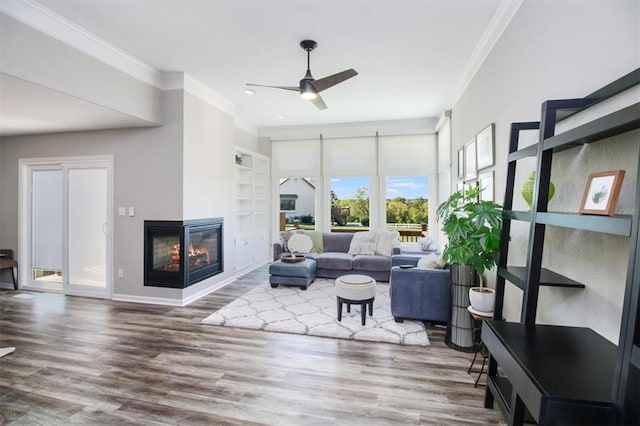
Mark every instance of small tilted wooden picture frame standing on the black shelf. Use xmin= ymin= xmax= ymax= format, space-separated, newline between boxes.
xmin=580 ymin=170 xmax=624 ymax=216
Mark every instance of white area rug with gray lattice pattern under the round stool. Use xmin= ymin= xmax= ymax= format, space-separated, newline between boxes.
xmin=202 ymin=278 xmax=429 ymax=346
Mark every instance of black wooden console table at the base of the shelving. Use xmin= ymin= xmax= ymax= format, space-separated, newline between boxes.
xmin=482 ymin=321 xmax=617 ymax=425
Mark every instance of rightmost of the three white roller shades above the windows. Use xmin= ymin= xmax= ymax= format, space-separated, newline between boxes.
xmin=378 ymin=134 xmax=437 ymax=176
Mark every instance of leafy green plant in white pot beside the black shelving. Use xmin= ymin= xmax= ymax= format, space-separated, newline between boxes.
xmin=436 ymin=187 xmax=502 ymax=312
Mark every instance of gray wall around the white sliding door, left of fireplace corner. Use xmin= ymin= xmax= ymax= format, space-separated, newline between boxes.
xmin=0 ymin=91 xmax=183 ymax=299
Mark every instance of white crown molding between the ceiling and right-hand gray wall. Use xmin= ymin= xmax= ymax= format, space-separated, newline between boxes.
xmin=447 ymin=0 xmax=523 ymax=108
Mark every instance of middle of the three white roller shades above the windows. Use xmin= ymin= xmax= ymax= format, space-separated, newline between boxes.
xmin=323 ymin=137 xmax=377 ymax=176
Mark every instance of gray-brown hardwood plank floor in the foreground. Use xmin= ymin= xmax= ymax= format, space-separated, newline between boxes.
xmin=0 ymin=268 xmax=504 ymax=425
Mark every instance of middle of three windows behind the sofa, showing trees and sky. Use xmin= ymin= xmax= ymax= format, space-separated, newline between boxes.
xmin=331 ymin=177 xmax=369 ymax=232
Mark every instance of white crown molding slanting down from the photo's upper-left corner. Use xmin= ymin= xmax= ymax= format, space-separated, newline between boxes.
xmin=0 ymin=0 xmax=162 ymax=88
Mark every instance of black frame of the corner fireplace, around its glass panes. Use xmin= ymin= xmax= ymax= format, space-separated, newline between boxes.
xmin=144 ymin=217 xmax=224 ymax=288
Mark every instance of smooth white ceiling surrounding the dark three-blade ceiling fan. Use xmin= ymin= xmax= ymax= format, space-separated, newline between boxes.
xmin=3 ymin=0 xmax=520 ymax=136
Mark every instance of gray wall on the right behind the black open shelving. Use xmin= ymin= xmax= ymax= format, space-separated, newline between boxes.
xmin=452 ymin=1 xmax=640 ymax=342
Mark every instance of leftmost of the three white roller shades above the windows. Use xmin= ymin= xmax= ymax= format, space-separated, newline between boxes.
xmin=271 ymin=139 xmax=321 ymax=178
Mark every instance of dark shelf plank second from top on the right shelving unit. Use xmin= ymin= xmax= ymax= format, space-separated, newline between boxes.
xmin=543 ymin=103 xmax=640 ymax=152
